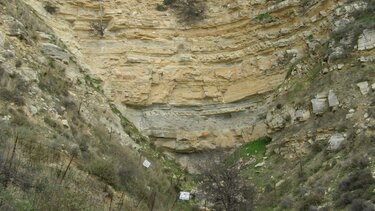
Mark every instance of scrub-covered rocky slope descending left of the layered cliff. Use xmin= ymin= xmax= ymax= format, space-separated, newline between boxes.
xmin=0 ymin=1 xmax=191 ymax=210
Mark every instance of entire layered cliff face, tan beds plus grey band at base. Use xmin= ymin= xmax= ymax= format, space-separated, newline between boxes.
xmin=24 ymin=0 xmax=339 ymax=161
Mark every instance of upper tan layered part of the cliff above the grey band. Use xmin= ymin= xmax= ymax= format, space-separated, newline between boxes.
xmin=23 ymin=0 xmax=340 ymax=105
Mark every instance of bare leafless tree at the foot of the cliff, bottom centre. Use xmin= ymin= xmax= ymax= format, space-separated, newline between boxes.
xmin=201 ymin=163 xmax=255 ymax=211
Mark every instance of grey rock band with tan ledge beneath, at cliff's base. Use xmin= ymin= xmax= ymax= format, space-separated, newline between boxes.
xmin=134 ymin=95 xmax=267 ymax=153
